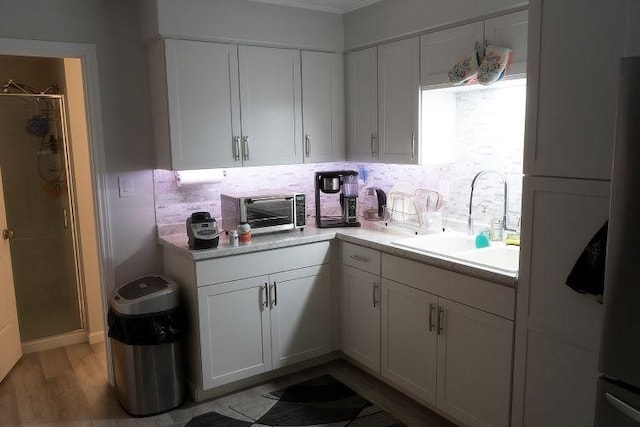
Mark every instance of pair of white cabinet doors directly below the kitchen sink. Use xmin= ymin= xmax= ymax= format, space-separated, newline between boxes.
xmin=382 ymin=279 xmax=513 ymax=426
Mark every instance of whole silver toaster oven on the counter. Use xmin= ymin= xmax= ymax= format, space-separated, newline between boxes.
xmin=220 ymin=193 xmax=307 ymax=234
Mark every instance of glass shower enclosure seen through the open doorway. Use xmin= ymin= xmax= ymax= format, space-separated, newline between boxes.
xmin=0 ymin=93 xmax=85 ymax=342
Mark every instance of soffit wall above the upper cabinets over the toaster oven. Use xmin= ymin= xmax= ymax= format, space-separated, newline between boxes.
xmin=149 ymin=0 xmax=343 ymax=51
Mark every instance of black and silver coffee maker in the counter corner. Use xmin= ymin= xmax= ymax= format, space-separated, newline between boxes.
xmin=315 ymin=171 xmax=360 ymax=228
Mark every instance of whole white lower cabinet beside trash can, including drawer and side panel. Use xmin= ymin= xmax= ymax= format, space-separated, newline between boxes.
xmin=163 ymin=241 xmax=337 ymax=401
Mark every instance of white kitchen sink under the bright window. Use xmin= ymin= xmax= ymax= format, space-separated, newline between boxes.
xmin=392 ymin=231 xmax=520 ymax=274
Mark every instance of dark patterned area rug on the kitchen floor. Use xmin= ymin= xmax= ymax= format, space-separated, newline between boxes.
xmin=187 ymin=375 xmax=404 ymax=427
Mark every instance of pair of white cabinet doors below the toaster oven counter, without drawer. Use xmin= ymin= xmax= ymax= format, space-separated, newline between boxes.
xmin=198 ymin=265 xmax=331 ymax=390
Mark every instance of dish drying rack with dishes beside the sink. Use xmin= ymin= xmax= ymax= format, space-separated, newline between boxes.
xmin=384 ymin=188 xmax=447 ymax=234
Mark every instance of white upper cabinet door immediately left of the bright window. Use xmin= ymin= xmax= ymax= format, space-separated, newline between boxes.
xmin=378 ymin=37 xmax=420 ymax=164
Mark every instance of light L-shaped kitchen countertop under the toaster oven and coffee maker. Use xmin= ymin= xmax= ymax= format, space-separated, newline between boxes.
xmin=158 ymin=223 xmax=517 ymax=287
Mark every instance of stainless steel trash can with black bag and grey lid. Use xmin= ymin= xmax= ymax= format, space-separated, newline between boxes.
xmin=108 ymin=276 xmax=184 ymax=416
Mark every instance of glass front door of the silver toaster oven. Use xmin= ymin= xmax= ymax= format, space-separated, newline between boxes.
xmin=244 ymin=197 xmax=295 ymax=233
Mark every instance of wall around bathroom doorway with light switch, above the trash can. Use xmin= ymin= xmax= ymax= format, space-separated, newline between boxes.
xmin=0 ymin=0 xmax=160 ymax=285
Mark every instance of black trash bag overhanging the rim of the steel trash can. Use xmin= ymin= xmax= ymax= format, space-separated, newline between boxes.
xmin=107 ymin=307 xmax=185 ymax=345
